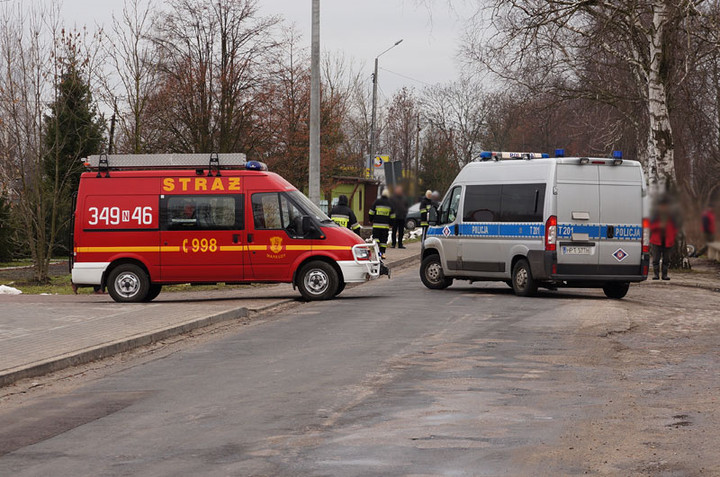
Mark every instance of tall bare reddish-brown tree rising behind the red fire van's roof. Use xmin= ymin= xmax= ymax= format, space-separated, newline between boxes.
xmin=154 ymin=0 xmax=279 ymax=152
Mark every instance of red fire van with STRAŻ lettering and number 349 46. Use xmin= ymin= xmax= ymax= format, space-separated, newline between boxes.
xmin=70 ymin=154 xmax=381 ymax=302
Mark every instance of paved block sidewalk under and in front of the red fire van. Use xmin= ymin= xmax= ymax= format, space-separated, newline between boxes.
xmin=0 ymin=243 xmax=420 ymax=386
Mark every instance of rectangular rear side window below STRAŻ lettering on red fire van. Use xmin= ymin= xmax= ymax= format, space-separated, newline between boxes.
xmin=164 ymin=195 xmax=243 ymax=230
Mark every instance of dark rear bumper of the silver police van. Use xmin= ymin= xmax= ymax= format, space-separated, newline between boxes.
xmin=528 ymin=250 xmax=650 ymax=283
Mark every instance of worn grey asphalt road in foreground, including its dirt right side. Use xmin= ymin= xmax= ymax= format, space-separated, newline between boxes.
xmin=0 ymin=269 xmax=720 ymax=476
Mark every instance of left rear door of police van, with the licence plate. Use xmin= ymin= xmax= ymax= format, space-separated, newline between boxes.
xmin=557 ymin=163 xmax=600 ymax=275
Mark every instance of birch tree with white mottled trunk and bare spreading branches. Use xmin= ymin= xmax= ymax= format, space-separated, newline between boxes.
xmin=465 ymin=0 xmax=708 ymax=191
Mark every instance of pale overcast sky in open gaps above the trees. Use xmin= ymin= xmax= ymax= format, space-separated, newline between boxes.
xmin=54 ymin=0 xmax=474 ymax=101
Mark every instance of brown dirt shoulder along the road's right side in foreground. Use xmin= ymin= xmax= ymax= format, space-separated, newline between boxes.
xmin=528 ymin=283 xmax=720 ymax=476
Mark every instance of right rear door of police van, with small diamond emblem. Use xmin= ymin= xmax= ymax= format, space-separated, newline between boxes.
xmin=598 ymin=165 xmax=643 ymax=275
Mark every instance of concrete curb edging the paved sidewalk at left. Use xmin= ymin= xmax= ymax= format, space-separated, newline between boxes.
xmin=0 ymin=300 xmax=249 ymax=387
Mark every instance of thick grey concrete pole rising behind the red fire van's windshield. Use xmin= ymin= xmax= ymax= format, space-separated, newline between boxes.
xmin=308 ymin=0 xmax=320 ymax=205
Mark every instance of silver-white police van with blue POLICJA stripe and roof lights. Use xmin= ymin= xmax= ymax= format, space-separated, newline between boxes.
xmin=420 ymin=149 xmax=650 ymax=298
